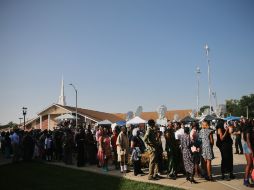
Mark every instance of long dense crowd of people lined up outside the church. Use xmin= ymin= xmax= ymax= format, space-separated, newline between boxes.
xmin=0 ymin=118 xmax=254 ymax=186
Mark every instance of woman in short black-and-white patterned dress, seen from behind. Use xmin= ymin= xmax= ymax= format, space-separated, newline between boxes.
xmin=199 ymin=120 xmax=214 ymax=181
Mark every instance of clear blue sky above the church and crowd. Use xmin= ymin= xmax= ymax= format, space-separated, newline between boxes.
xmin=0 ymin=0 xmax=254 ymax=124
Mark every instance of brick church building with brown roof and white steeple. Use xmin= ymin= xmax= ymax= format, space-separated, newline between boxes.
xmin=23 ymin=79 xmax=191 ymax=130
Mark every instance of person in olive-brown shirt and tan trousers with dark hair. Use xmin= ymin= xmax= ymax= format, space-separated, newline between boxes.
xmin=144 ymin=119 xmax=158 ymax=180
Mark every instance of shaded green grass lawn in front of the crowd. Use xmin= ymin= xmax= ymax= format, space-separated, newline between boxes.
xmin=0 ymin=162 xmax=183 ymax=190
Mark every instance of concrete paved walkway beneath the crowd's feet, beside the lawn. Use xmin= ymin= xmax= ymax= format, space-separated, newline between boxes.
xmin=0 ymin=147 xmax=250 ymax=190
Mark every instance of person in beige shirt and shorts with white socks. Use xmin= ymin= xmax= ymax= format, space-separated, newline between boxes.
xmin=116 ymin=127 xmax=129 ymax=173
